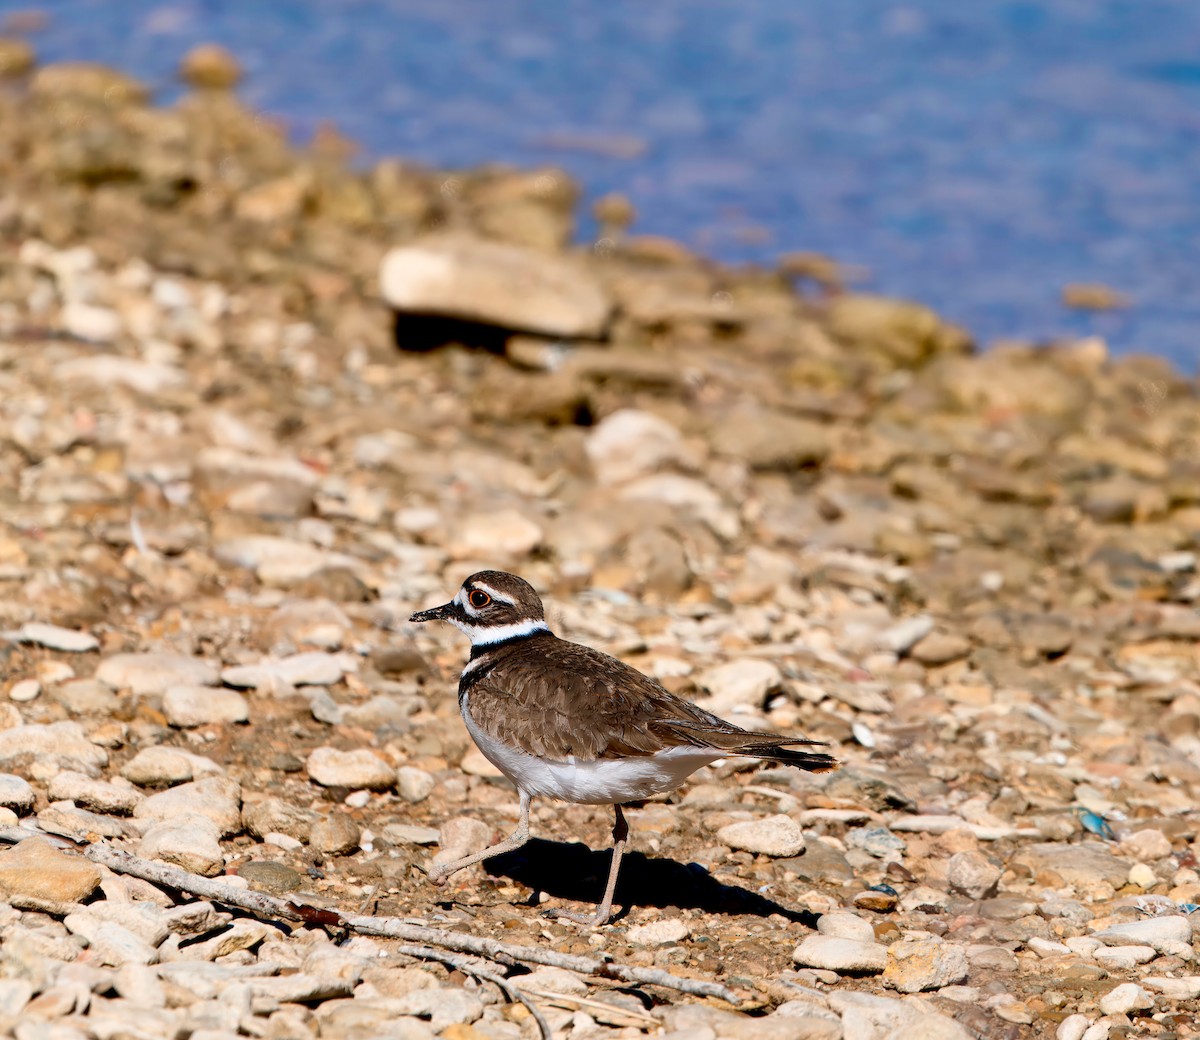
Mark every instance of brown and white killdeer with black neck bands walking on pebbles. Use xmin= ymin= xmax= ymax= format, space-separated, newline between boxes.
xmin=410 ymin=571 xmax=836 ymax=926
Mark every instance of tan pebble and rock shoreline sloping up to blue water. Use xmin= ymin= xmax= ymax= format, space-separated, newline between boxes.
xmin=0 ymin=44 xmax=1200 ymax=1040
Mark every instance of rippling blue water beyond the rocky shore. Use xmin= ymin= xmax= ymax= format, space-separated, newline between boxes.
xmin=9 ymin=0 xmax=1200 ymax=372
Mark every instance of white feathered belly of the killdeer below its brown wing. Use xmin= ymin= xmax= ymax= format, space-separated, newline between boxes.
xmin=462 ymin=695 xmax=725 ymax=805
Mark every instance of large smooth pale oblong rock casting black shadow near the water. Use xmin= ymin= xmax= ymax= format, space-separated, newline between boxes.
xmin=379 ymin=234 xmax=612 ymax=338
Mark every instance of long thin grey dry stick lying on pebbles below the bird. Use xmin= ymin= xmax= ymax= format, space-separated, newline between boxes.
xmin=85 ymin=842 xmax=742 ymax=1004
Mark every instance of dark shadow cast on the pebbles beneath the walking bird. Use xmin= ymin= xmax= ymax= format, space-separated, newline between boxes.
xmin=484 ymin=837 xmax=817 ymax=927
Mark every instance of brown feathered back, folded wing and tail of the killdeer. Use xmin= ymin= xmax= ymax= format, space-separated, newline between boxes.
xmin=458 ymin=637 xmax=835 ymax=770
